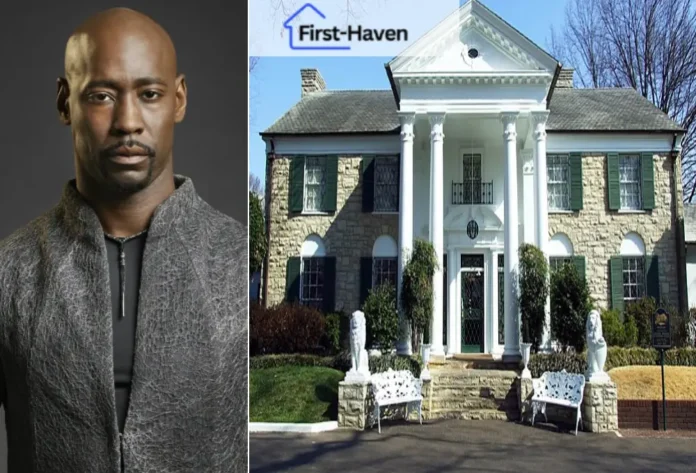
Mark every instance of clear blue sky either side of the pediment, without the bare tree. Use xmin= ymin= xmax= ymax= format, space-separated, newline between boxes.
xmin=249 ymin=0 xmax=567 ymax=181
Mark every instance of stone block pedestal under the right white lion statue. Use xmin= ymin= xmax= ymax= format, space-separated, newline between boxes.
xmin=581 ymin=383 xmax=619 ymax=433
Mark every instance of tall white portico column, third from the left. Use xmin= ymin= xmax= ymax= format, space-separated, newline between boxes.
xmin=501 ymin=112 xmax=521 ymax=359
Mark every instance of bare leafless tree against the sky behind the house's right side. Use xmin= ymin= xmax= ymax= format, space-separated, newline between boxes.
xmin=551 ymin=0 xmax=696 ymax=202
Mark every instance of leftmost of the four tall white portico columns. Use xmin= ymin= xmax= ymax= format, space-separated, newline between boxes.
xmin=397 ymin=113 xmax=416 ymax=355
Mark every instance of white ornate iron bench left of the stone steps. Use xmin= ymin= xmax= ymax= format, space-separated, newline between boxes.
xmin=370 ymin=368 xmax=423 ymax=433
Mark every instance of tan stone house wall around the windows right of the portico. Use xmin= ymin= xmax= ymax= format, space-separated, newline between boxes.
xmin=549 ymin=155 xmax=683 ymax=308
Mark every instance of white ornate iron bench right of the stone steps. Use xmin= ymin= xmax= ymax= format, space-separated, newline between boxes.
xmin=531 ymin=370 xmax=585 ymax=435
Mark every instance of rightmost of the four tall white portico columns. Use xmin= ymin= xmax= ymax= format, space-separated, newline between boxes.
xmin=532 ymin=111 xmax=551 ymax=350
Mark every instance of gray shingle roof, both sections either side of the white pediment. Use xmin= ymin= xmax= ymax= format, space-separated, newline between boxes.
xmin=262 ymin=89 xmax=683 ymax=135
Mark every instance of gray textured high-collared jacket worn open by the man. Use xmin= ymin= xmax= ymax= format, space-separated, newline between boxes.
xmin=0 ymin=176 xmax=248 ymax=473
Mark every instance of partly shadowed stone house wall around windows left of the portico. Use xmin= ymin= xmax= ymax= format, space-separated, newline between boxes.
xmin=266 ymin=156 xmax=399 ymax=314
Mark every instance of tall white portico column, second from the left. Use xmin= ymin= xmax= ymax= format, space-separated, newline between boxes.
xmin=429 ymin=113 xmax=445 ymax=357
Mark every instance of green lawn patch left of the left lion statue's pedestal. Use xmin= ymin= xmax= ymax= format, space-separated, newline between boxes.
xmin=249 ymin=366 xmax=344 ymax=423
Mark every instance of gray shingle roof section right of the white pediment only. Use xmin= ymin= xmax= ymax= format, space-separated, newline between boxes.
xmin=546 ymin=88 xmax=683 ymax=131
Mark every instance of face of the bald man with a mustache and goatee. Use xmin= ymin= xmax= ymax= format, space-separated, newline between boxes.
xmin=58 ymin=30 xmax=186 ymax=195
